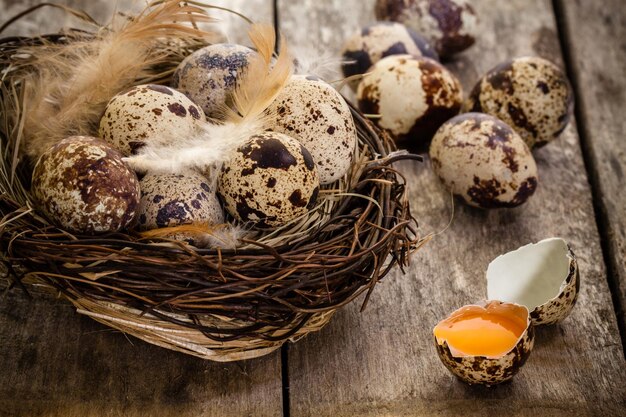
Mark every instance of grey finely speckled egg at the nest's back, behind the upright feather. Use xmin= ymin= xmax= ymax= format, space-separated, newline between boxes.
xmin=172 ymin=43 xmax=254 ymax=118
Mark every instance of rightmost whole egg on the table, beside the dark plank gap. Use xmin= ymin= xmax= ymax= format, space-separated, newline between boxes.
xmin=464 ymin=57 xmax=574 ymax=149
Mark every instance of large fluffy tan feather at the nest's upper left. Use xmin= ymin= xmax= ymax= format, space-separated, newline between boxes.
xmin=19 ymin=0 xmax=218 ymax=160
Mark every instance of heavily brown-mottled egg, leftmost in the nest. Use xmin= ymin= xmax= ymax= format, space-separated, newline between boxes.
xmin=31 ymin=136 xmax=139 ymax=234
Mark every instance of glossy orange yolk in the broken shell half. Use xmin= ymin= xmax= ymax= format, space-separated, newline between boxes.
xmin=434 ymin=311 xmax=526 ymax=357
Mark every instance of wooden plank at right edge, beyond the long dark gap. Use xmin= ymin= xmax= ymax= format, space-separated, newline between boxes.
xmin=558 ymin=0 xmax=626 ymax=343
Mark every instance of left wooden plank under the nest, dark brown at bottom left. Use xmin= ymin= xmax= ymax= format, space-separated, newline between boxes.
xmin=0 ymin=0 xmax=283 ymax=417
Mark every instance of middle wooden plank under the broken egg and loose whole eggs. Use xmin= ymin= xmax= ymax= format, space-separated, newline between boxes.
xmin=279 ymin=0 xmax=626 ymax=417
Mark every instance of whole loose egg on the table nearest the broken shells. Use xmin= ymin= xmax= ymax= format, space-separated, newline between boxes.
xmin=430 ymin=113 xmax=537 ymax=209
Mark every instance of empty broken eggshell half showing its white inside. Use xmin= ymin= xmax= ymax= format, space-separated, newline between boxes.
xmin=487 ymin=238 xmax=580 ymax=325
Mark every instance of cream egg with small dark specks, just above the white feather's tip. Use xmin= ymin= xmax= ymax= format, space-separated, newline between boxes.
xmin=99 ymin=84 xmax=204 ymax=156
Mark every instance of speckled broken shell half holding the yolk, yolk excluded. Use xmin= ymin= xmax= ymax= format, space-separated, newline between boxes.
xmin=434 ymin=301 xmax=535 ymax=386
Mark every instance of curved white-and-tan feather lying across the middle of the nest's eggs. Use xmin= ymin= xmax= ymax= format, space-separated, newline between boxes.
xmin=126 ymin=24 xmax=293 ymax=172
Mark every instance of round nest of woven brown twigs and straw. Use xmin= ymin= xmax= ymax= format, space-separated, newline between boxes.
xmin=0 ymin=2 xmax=425 ymax=361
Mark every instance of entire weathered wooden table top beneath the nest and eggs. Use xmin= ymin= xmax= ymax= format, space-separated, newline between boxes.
xmin=0 ymin=0 xmax=626 ymax=417
